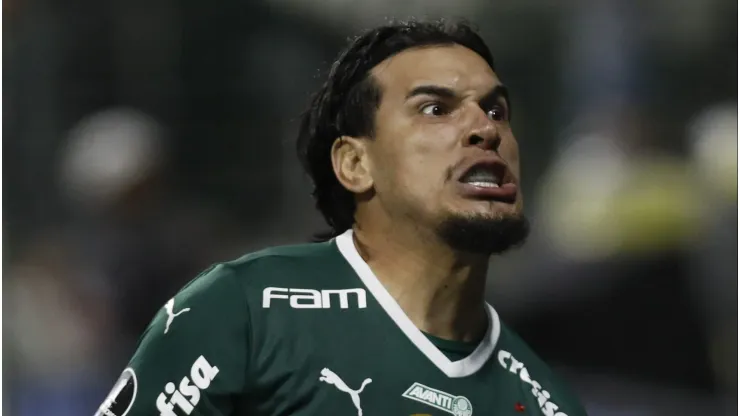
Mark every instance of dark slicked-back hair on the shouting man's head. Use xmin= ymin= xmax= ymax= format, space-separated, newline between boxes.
xmin=297 ymin=20 xmax=494 ymax=241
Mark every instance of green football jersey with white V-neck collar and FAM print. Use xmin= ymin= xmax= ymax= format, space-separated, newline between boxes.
xmin=98 ymin=231 xmax=585 ymax=416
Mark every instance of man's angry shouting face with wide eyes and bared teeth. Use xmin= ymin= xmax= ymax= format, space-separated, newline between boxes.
xmin=368 ymin=45 xmax=526 ymax=253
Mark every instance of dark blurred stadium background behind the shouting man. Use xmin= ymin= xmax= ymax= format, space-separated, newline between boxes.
xmin=2 ymin=0 xmax=738 ymax=416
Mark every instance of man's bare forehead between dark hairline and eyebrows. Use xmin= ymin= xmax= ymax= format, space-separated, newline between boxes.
xmin=371 ymin=45 xmax=501 ymax=95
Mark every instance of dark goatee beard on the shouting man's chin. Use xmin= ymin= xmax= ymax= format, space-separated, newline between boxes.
xmin=437 ymin=215 xmax=529 ymax=256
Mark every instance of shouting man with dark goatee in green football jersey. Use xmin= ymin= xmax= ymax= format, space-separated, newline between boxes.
xmin=99 ymin=17 xmax=585 ymax=416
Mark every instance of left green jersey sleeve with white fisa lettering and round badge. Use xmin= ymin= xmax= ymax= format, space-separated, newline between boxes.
xmin=96 ymin=265 xmax=250 ymax=416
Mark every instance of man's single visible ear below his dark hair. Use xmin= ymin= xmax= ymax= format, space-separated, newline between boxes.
xmin=331 ymin=136 xmax=373 ymax=194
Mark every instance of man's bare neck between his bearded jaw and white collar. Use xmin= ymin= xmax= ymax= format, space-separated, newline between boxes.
xmin=354 ymin=221 xmax=488 ymax=341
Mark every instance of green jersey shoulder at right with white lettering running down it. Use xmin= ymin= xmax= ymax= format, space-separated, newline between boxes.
xmin=496 ymin=324 xmax=586 ymax=416
